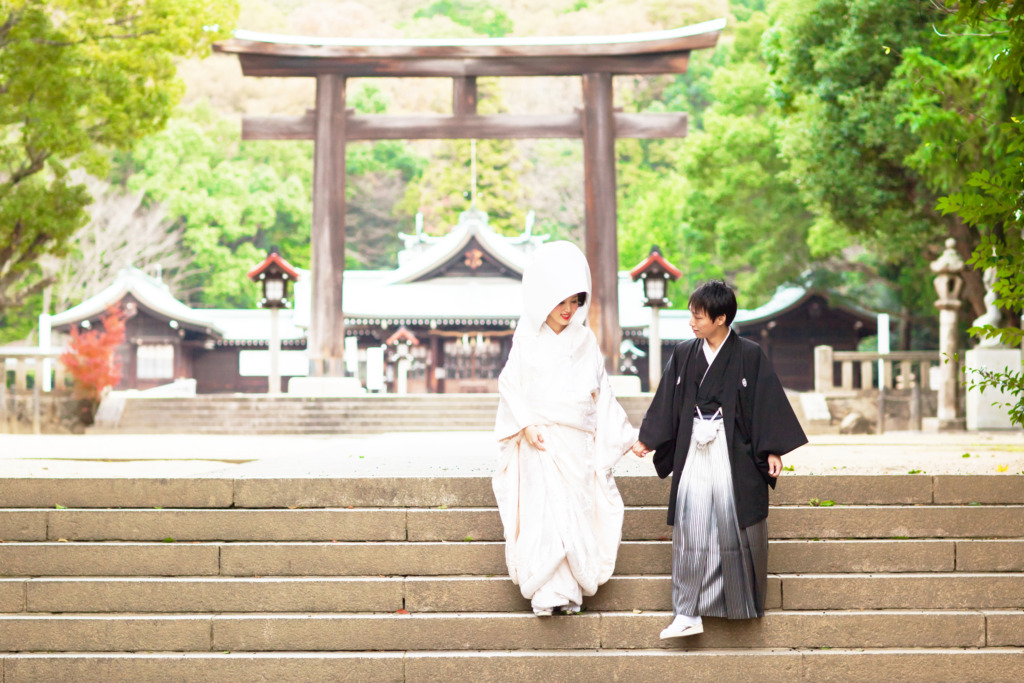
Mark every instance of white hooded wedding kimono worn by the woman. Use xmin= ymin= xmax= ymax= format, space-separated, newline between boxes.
xmin=494 ymin=242 xmax=637 ymax=610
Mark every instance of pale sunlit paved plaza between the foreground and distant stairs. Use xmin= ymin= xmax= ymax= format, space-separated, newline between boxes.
xmin=0 ymin=430 xmax=1024 ymax=477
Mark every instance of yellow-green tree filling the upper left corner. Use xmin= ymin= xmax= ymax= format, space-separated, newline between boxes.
xmin=0 ymin=0 xmax=238 ymax=318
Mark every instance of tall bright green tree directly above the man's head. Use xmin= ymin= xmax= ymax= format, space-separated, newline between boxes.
xmin=681 ymin=12 xmax=813 ymax=306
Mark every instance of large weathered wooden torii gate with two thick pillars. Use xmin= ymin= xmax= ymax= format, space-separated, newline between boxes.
xmin=214 ymin=19 xmax=725 ymax=377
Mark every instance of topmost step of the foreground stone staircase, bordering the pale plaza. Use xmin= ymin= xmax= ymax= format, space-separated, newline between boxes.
xmin=0 ymin=473 xmax=1024 ymax=509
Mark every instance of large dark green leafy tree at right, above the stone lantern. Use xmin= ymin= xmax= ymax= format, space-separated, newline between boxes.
xmin=762 ymin=0 xmax=984 ymax=347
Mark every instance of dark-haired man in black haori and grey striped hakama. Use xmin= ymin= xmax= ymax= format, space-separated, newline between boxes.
xmin=633 ymin=281 xmax=807 ymax=639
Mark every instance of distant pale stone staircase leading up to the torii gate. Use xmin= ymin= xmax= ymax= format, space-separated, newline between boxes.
xmin=89 ymin=393 xmax=650 ymax=434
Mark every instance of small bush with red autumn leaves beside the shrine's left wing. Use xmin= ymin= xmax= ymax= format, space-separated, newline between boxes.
xmin=60 ymin=305 xmax=125 ymax=403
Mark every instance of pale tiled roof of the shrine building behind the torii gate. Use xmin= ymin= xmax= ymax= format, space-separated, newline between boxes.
xmin=51 ymin=219 xmax=871 ymax=342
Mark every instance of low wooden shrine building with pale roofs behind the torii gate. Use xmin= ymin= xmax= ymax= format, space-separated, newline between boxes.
xmin=50 ymin=211 xmax=876 ymax=393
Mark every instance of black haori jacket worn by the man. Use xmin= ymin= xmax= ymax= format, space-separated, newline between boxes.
xmin=640 ymin=332 xmax=807 ymax=528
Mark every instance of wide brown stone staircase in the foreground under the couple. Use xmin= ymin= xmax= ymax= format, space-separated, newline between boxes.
xmin=0 ymin=475 xmax=1024 ymax=683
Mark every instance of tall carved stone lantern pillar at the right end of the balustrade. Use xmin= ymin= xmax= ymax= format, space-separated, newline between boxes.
xmin=932 ymin=238 xmax=965 ymax=431
